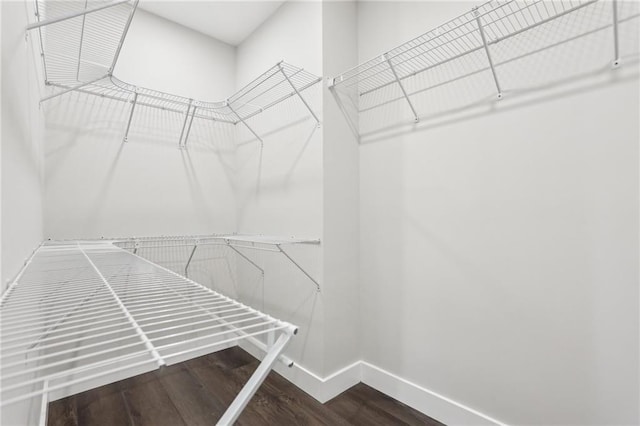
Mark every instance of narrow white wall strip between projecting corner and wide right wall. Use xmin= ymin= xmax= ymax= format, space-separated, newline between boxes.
xmin=322 ymin=1 xmax=366 ymax=373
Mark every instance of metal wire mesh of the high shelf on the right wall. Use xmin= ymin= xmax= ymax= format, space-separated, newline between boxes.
xmin=333 ymin=0 xmax=640 ymax=135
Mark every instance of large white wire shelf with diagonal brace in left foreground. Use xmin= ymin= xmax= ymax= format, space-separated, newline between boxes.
xmin=0 ymin=241 xmax=297 ymax=425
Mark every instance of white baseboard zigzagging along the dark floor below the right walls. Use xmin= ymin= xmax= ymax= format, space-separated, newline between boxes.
xmin=235 ymin=341 xmax=507 ymax=426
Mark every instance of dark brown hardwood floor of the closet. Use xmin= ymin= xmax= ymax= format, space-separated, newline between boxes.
xmin=48 ymin=347 xmax=441 ymax=426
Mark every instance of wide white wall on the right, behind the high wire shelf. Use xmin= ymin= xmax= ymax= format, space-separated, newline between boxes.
xmin=358 ymin=2 xmax=640 ymax=425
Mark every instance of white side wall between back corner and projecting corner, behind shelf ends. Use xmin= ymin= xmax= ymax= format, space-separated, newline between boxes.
xmin=236 ymin=2 xmax=326 ymax=381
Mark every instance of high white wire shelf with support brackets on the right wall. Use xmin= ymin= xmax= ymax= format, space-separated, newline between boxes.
xmin=329 ymin=0 xmax=640 ymax=138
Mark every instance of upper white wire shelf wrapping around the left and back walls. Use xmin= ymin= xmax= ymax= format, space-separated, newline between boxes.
xmin=27 ymin=0 xmax=321 ymax=147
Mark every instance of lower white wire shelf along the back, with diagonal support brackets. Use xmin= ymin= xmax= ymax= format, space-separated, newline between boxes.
xmin=114 ymin=234 xmax=320 ymax=292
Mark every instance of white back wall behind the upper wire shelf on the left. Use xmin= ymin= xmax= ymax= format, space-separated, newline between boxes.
xmin=45 ymin=10 xmax=236 ymax=238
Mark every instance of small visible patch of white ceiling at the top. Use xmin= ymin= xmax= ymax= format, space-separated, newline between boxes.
xmin=138 ymin=0 xmax=284 ymax=46
